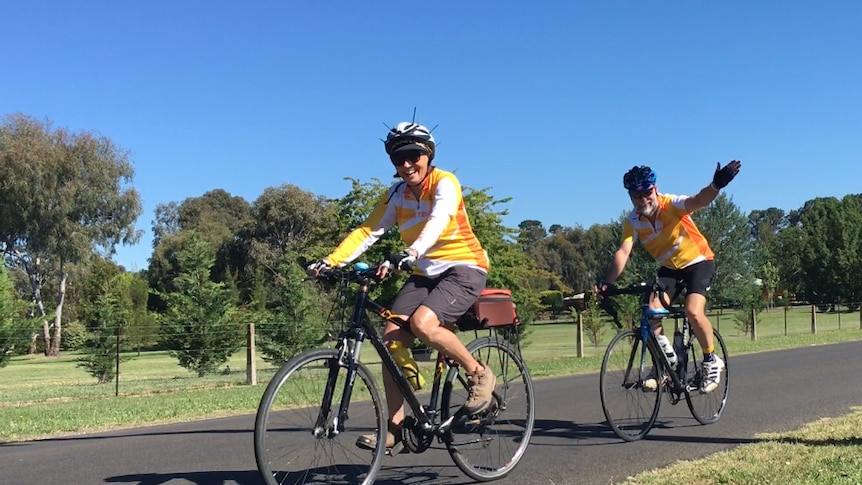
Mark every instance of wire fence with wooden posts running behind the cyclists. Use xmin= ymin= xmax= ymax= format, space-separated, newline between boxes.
xmin=6 ymin=303 xmax=862 ymax=400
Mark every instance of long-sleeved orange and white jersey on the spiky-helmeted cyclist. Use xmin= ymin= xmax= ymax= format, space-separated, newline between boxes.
xmin=326 ymin=168 xmax=489 ymax=276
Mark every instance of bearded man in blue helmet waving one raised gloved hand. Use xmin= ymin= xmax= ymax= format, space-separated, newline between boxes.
xmin=596 ymin=160 xmax=742 ymax=393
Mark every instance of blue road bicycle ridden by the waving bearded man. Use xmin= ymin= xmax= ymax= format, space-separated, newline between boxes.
xmin=599 ymin=283 xmax=729 ymax=441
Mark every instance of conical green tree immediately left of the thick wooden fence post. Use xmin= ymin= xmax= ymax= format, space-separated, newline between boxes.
xmin=160 ymin=235 xmax=244 ymax=377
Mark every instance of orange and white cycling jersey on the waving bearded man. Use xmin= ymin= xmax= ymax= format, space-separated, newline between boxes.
xmin=623 ymin=194 xmax=715 ymax=269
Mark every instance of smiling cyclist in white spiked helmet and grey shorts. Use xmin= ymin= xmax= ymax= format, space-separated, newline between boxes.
xmin=308 ymin=122 xmax=496 ymax=450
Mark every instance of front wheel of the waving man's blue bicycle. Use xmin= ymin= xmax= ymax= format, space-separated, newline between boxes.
xmin=599 ymin=330 xmax=664 ymax=441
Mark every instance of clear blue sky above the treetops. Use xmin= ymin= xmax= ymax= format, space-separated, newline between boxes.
xmin=0 ymin=0 xmax=862 ymax=269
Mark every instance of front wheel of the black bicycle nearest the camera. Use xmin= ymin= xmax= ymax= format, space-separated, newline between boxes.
xmin=254 ymin=349 xmax=386 ymax=485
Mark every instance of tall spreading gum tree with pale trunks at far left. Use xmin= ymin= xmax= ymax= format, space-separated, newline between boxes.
xmin=0 ymin=114 xmax=141 ymax=356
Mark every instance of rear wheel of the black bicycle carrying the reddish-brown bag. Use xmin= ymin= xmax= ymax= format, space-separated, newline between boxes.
xmin=441 ymin=337 xmax=536 ymax=482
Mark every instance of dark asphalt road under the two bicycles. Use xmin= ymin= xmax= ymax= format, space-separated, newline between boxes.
xmin=0 ymin=342 xmax=862 ymax=485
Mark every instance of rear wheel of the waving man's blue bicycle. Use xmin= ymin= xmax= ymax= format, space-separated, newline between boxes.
xmin=685 ymin=329 xmax=730 ymax=424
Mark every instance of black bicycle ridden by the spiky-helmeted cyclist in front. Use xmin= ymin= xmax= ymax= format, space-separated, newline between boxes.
xmin=254 ymin=263 xmax=535 ymax=485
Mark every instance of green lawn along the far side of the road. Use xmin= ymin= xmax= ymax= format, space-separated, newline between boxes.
xmin=0 ymin=308 xmax=862 ymax=441
